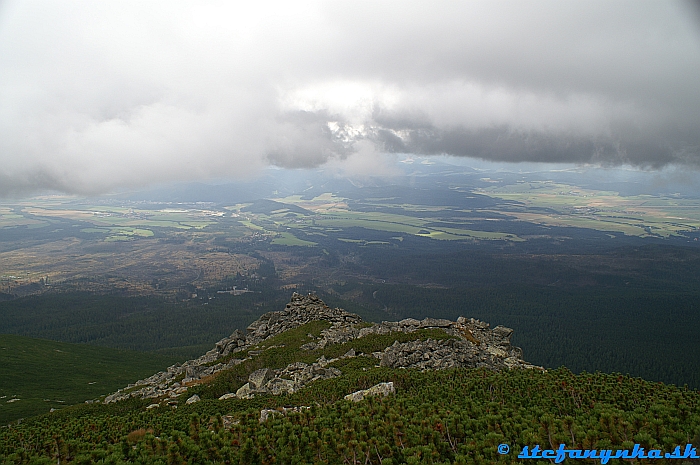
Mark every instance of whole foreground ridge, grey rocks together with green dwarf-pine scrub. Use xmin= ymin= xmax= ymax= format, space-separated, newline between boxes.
xmin=0 ymin=294 xmax=700 ymax=465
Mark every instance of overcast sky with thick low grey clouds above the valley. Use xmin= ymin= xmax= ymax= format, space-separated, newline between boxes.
xmin=0 ymin=0 xmax=700 ymax=196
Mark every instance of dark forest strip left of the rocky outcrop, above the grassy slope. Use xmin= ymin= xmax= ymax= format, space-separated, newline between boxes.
xmin=0 ymin=291 xmax=289 ymax=358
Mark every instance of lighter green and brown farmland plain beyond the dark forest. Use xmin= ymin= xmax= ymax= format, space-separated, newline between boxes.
xmin=0 ymin=181 xmax=700 ymax=295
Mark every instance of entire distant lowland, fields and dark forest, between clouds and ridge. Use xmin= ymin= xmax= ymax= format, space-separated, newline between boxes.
xmin=0 ymin=166 xmax=700 ymax=422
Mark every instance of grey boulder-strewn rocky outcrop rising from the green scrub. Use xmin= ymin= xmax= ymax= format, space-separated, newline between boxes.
xmin=104 ymin=293 xmax=542 ymax=403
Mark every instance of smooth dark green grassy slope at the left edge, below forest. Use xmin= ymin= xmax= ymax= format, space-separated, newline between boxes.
xmin=0 ymin=334 xmax=178 ymax=424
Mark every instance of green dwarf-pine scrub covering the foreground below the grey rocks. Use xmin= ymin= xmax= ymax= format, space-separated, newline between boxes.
xmin=0 ymin=322 xmax=700 ymax=465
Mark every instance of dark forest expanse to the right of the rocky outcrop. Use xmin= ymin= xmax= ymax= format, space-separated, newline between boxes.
xmin=337 ymin=284 xmax=700 ymax=389
